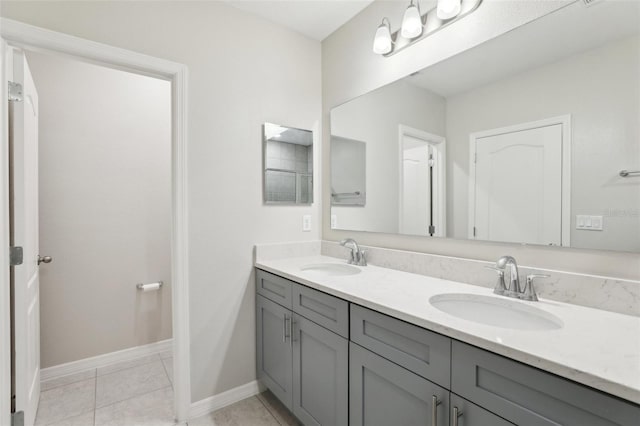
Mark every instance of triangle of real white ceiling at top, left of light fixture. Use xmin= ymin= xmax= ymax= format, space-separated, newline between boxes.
xmin=224 ymin=0 xmax=373 ymax=41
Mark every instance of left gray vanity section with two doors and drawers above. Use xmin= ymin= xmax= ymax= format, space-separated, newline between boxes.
xmin=256 ymin=270 xmax=349 ymax=426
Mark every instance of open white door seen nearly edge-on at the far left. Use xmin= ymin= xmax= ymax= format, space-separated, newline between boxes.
xmin=9 ymin=49 xmax=40 ymax=425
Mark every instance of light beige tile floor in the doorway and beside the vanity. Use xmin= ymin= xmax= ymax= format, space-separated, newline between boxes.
xmin=36 ymin=352 xmax=299 ymax=426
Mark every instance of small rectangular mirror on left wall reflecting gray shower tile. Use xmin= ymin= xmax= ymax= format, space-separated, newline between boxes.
xmin=262 ymin=123 xmax=313 ymax=204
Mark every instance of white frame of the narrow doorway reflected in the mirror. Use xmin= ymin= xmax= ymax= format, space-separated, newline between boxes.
xmin=398 ymin=124 xmax=447 ymax=237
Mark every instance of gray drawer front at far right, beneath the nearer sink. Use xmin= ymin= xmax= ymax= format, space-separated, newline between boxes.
xmin=451 ymin=341 xmax=640 ymax=426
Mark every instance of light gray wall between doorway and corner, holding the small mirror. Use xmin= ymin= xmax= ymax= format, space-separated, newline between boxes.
xmin=0 ymin=1 xmax=321 ymax=401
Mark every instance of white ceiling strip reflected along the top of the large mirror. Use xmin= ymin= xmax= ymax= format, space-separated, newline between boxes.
xmin=408 ymin=1 xmax=640 ymax=97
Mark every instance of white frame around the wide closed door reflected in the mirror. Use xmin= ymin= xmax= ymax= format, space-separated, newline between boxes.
xmin=467 ymin=114 xmax=571 ymax=247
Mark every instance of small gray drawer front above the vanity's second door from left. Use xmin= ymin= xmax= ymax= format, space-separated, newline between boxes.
xmin=292 ymin=284 xmax=349 ymax=339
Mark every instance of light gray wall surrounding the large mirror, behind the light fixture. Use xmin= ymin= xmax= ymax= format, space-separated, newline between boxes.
xmin=322 ymin=0 xmax=640 ymax=279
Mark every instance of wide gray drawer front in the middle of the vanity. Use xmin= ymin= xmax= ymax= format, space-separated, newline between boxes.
xmin=351 ymin=304 xmax=451 ymax=388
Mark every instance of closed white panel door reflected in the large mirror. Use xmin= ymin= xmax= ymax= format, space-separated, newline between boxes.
xmin=471 ymin=124 xmax=562 ymax=245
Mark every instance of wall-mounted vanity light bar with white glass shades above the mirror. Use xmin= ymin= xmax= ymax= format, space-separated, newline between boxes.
xmin=373 ymin=0 xmax=482 ymax=56
